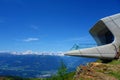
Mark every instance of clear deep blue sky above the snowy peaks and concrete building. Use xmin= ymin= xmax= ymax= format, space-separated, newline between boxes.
xmin=0 ymin=0 xmax=120 ymax=52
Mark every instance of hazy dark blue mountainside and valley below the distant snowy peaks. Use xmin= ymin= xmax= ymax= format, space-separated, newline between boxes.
xmin=0 ymin=53 xmax=95 ymax=77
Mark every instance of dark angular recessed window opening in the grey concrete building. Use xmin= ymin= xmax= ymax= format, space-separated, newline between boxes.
xmin=90 ymin=20 xmax=114 ymax=46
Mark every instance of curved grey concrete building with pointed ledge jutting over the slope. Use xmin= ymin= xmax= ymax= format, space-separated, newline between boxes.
xmin=65 ymin=13 xmax=120 ymax=59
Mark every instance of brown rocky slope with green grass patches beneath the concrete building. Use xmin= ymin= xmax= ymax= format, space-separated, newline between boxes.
xmin=74 ymin=60 xmax=120 ymax=80
